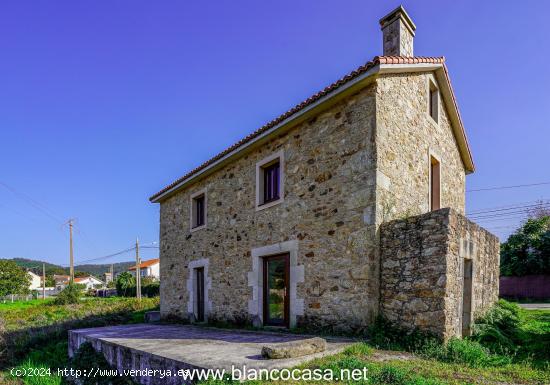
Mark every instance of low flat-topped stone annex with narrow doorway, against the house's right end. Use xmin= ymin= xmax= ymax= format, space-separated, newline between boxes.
xmin=380 ymin=208 xmax=500 ymax=339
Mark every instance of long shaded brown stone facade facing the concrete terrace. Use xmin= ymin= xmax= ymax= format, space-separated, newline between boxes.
xmin=160 ymin=84 xmax=379 ymax=329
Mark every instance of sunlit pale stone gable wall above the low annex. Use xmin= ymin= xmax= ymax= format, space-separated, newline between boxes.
xmin=376 ymin=73 xmax=466 ymax=224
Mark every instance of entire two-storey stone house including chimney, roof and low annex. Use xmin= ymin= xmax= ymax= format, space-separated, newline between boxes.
xmin=150 ymin=7 xmax=499 ymax=338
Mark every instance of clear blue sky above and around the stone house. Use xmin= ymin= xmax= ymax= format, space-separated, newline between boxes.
xmin=0 ymin=0 xmax=550 ymax=264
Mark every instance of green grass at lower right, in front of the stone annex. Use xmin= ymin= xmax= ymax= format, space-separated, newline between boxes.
xmin=198 ymin=301 xmax=550 ymax=385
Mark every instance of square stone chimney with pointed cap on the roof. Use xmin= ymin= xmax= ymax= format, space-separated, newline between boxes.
xmin=380 ymin=5 xmax=416 ymax=56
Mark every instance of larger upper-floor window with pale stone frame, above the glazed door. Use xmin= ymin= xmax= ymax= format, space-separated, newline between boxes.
xmin=256 ymin=151 xmax=284 ymax=210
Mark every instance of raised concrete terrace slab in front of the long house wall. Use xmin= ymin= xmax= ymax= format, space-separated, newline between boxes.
xmin=69 ymin=324 xmax=353 ymax=384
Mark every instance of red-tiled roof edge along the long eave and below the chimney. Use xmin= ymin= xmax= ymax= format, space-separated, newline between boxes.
xmin=149 ymin=56 xmax=447 ymax=201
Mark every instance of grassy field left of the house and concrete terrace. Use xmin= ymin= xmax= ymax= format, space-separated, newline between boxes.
xmin=0 ymin=297 xmax=159 ymax=385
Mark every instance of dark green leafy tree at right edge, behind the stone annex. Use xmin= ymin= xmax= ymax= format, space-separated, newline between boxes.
xmin=500 ymin=216 xmax=550 ymax=276
